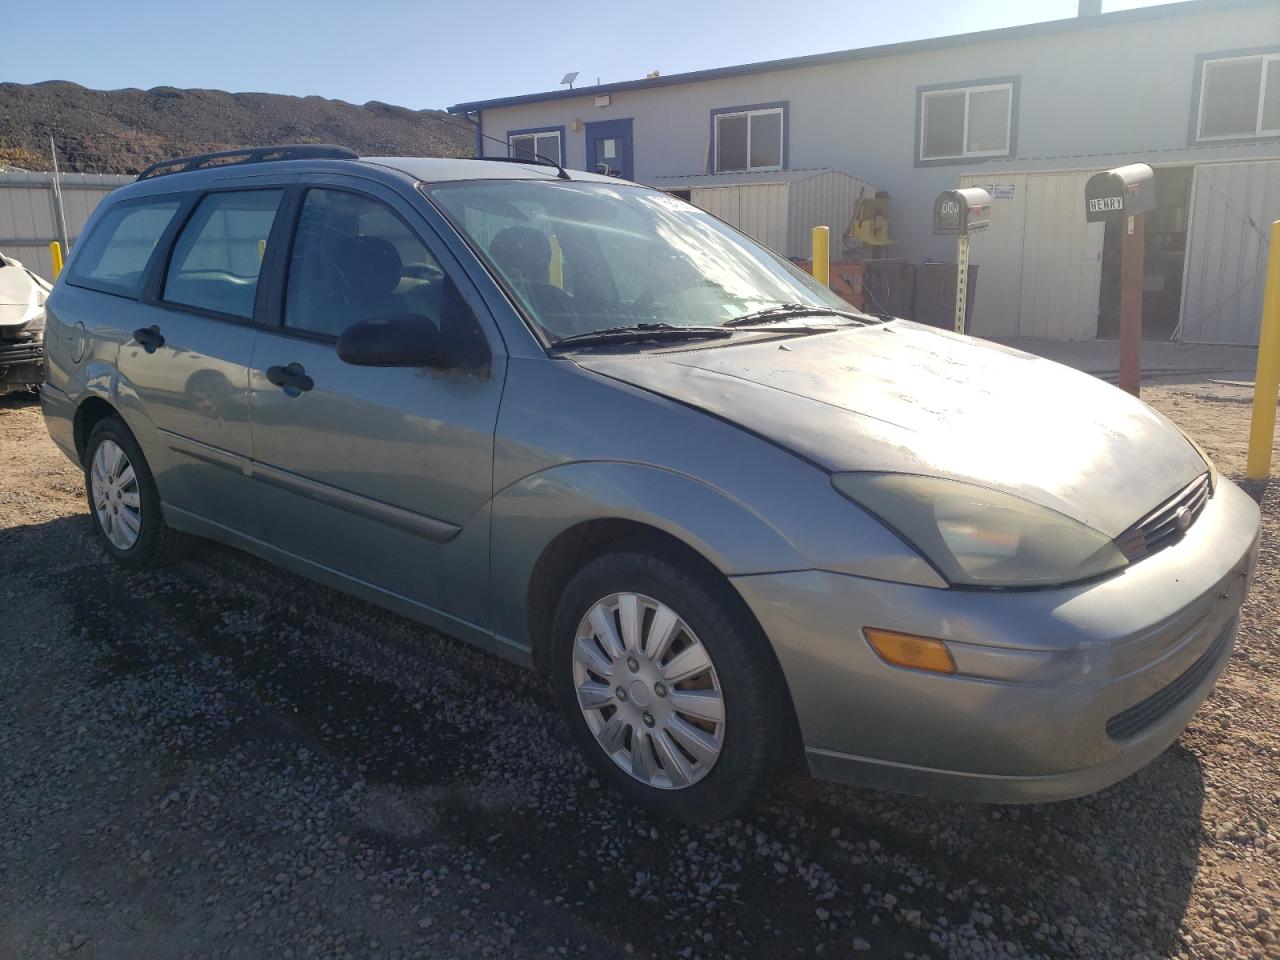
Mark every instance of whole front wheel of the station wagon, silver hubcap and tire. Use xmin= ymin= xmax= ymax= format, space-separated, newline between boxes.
xmin=553 ymin=552 xmax=794 ymax=822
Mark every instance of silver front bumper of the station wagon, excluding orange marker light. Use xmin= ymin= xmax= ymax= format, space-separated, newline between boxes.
xmin=733 ymin=480 xmax=1258 ymax=803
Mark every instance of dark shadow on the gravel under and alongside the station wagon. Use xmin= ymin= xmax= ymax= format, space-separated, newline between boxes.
xmin=6 ymin=516 xmax=1204 ymax=957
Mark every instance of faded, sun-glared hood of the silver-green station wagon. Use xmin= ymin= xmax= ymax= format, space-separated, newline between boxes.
xmin=575 ymin=320 xmax=1207 ymax=536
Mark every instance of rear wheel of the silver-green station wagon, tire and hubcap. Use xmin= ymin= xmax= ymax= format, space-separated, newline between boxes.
xmin=84 ymin=416 xmax=195 ymax=567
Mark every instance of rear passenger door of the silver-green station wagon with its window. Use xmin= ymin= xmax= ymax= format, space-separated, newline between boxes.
xmin=118 ymin=186 xmax=284 ymax=535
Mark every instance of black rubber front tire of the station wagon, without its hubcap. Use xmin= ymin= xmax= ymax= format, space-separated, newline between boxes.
xmin=550 ymin=550 xmax=797 ymax=823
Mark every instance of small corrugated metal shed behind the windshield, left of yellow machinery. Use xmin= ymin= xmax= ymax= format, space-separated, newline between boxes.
xmin=652 ymin=168 xmax=876 ymax=260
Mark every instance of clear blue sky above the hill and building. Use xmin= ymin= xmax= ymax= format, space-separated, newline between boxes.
xmin=0 ymin=0 xmax=1177 ymax=109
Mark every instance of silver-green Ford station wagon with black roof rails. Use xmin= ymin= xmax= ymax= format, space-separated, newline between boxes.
xmin=41 ymin=146 xmax=1258 ymax=820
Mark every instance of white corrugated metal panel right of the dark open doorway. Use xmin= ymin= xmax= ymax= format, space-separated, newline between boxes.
xmin=1178 ymin=160 xmax=1280 ymax=346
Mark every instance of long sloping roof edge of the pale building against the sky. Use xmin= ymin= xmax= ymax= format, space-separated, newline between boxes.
xmin=447 ymin=0 xmax=1259 ymax=114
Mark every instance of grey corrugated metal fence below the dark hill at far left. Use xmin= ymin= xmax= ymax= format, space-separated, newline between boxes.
xmin=0 ymin=170 xmax=134 ymax=279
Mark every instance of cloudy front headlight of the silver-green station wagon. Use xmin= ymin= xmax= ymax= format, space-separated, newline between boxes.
xmin=832 ymin=474 xmax=1128 ymax=586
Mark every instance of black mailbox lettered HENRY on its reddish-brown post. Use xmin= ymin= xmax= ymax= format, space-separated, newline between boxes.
xmin=1084 ymin=164 xmax=1156 ymax=397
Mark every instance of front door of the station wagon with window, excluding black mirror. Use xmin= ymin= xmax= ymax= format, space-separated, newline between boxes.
xmin=250 ymin=178 xmax=506 ymax=632
